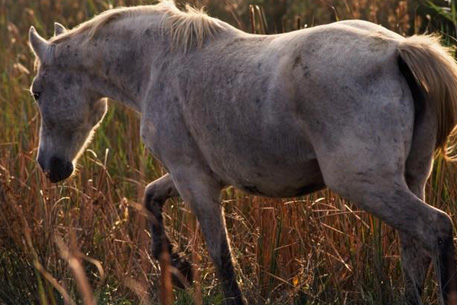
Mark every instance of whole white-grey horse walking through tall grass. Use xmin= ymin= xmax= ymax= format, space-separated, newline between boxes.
xmin=29 ymin=1 xmax=457 ymax=305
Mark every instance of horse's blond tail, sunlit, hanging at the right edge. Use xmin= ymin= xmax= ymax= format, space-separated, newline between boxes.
xmin=398 ymin=35 xmax=457 ymax=157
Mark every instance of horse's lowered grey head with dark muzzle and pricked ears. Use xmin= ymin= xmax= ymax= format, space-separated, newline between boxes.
xmin=29 ymin=26 xmax=107 ymax=182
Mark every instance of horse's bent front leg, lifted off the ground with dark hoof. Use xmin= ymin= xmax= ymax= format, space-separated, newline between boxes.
xmin=145 ymin=174 xmax=192 ymax=288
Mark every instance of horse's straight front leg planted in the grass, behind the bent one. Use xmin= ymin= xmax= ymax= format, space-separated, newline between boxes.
xmin=171 ymin=166 xmax=246 ymax=305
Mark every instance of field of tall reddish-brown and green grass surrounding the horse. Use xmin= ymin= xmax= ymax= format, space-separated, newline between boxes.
xmin=0 ymin=0 xmax=457 ymax=305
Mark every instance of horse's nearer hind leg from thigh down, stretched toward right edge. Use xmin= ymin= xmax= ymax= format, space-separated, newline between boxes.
xmin=320 ymin=154 xmax=457 ymax=305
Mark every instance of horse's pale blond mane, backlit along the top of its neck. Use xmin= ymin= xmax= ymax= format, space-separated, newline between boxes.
xmin=50 ymin=0 xmax=221 ymax=51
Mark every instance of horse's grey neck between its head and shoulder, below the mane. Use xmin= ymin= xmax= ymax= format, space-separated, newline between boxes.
xmin=67 ymin=15 xmax=165 ymax=112
